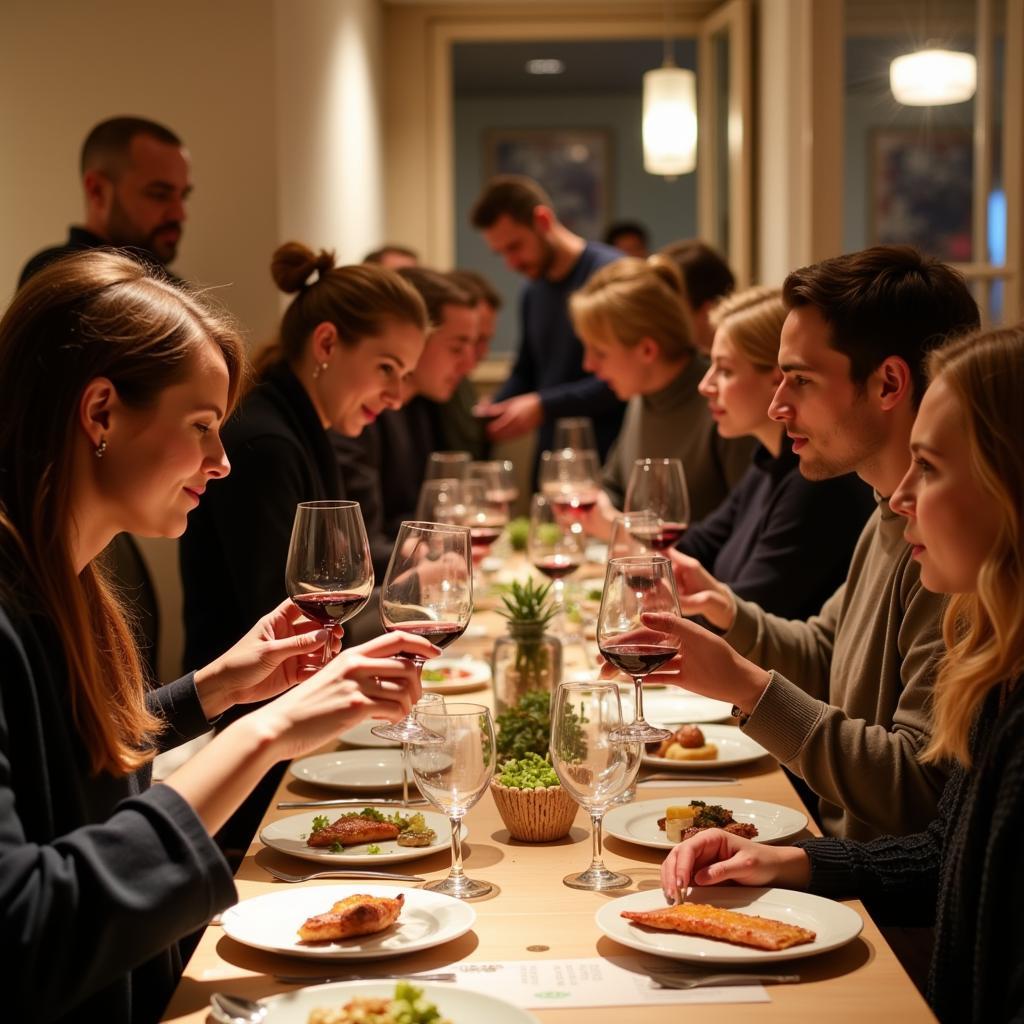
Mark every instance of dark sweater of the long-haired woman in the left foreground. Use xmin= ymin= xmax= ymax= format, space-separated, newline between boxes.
xmin=0 ymin=607 xmax=237 ymax=1024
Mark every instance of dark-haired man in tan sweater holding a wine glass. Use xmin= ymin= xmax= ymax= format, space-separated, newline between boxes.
xmin=626 ymin=246 xmax=978 ymax=839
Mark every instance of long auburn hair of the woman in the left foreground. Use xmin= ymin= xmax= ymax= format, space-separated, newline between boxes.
xmin=0 ymin=249 xmax=245 ymax=774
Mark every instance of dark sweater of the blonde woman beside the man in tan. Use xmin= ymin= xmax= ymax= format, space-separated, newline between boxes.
xmin=677 ymin=437 xmax=874 ymax=618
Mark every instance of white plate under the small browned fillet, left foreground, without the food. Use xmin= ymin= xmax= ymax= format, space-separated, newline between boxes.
xmin=223 ymin=882 xmax=476 ymax=959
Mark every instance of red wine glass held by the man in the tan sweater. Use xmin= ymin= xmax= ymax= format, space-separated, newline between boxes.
xmin=597 ymin=555 xmax=679 ymax=743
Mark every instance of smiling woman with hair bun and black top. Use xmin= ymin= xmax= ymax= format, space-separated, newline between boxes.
xmin=180 ymin=242 xmax=427 ymax=851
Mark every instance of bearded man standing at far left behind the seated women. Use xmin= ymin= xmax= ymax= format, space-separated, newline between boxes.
xmin=18 ymin=117 xmax=193 ymax=287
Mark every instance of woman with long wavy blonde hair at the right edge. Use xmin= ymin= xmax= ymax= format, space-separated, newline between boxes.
xmin=662 ymin=325 xmax=1024 ymax=1024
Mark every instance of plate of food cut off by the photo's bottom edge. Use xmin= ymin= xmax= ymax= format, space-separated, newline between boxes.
xmin=262 ymin=979 xmax=537 ymax=1024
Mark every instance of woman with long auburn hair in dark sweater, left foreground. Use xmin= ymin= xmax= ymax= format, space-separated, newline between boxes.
xmin=0 ymin=251 xmax=436 ymax=1024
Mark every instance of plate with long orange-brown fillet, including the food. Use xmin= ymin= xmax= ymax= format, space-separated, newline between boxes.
xmin=597 ymin=886 xmax=864 ymax=965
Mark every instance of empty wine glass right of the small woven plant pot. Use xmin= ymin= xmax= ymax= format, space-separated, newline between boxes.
xmin=550 ymin=682 xmax=641 ymax=891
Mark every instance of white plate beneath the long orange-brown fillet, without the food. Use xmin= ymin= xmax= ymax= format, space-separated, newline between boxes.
xmin=597 ymin=886 xmax=864 ymax=964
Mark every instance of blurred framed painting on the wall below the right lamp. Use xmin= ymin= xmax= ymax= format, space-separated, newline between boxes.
xmin=868 ymin=126 xmax=974 ymax=263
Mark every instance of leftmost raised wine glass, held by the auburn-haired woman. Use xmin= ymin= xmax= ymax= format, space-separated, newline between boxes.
xmin=285 ymin=501 xmax=374 ymax=665
